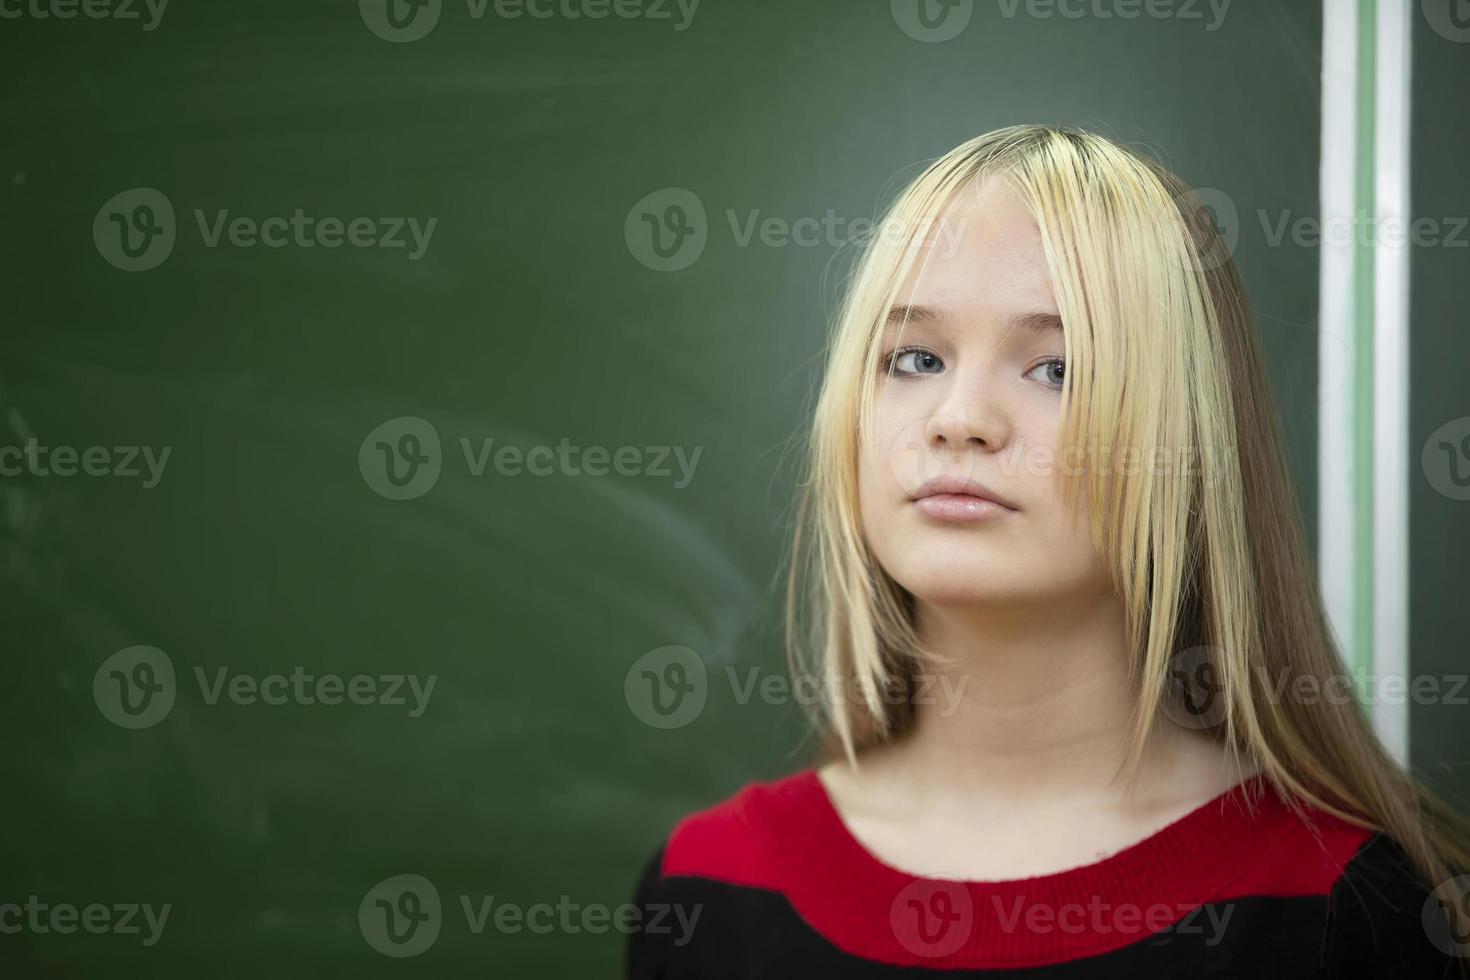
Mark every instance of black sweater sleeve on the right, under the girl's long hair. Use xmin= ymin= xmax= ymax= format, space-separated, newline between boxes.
xmin=1323 ymin=835 xmax=1470 ymax=980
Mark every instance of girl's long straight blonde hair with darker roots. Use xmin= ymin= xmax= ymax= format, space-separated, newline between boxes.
xmin=786 ymin=126 xmax=1470 ymax=899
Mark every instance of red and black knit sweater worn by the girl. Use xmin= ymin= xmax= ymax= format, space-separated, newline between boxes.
xmin=626 ymin=770 xmax=1461 ymax=980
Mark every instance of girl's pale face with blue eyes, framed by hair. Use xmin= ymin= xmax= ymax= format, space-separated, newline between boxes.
xmin=858 ymin=178 xmax=1111 ymax=605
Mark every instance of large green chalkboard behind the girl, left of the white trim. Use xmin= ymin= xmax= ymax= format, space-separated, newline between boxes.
xmin=0 ymin=0 xmax=1320 ymax=979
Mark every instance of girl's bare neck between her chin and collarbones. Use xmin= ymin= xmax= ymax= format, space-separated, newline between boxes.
xmin=875 ymin=594 xmax=1239 ymax=813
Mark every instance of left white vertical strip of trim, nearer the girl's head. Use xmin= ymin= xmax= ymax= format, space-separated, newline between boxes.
xmin=1317 ymin=0 xmax=1358 ymax=696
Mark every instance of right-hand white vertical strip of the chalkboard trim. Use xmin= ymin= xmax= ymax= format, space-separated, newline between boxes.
xmin=1373 ymin=0 xmax=1416 ymax=764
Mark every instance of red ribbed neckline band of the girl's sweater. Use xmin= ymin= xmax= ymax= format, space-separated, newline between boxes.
xmin=775 ymin=768 xmax=1361 ymax=970
